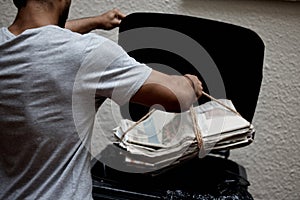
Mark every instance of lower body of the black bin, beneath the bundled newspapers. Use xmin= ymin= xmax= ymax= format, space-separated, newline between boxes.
xmin=92 ymin=156 xmax=253 ymax=200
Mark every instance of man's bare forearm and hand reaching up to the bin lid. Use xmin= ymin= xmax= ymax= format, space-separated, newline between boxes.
xmin=65 ymin=9 xmax=125 ymax=34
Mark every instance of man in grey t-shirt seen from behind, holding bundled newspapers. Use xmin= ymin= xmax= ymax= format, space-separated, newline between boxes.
xmin=0 ymin=0 xmax=202 ymax=200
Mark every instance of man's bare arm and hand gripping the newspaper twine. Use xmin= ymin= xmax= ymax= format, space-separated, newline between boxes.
xmin=130 ymin=70 xmax=203 ymax=112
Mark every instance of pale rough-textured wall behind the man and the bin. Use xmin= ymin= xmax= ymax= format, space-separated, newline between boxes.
xmin=0 ymin=0 xmax=300 ymax=200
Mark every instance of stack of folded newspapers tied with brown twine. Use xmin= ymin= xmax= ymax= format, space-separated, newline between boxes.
xmin=114 ymin=99 xmax=255 ymax=169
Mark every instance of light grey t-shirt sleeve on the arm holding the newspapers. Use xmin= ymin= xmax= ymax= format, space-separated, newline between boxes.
xmin=80 ymin=35 xmax=152 ymax=105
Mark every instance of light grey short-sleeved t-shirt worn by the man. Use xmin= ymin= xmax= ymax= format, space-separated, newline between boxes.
xmin=0 ymin=25 xmax=151 ymax=200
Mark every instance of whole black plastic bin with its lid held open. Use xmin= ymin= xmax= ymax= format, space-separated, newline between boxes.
xmin=92 ymin=13 xmax=264 ymax=200
